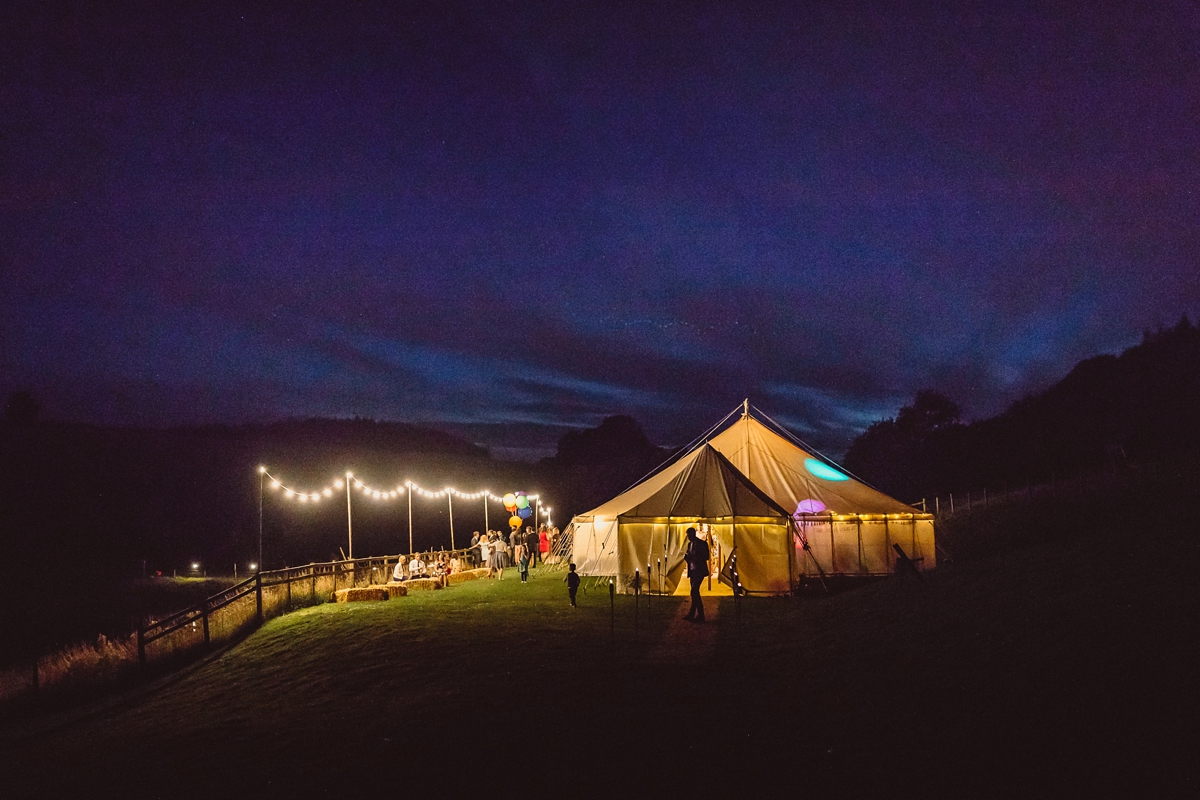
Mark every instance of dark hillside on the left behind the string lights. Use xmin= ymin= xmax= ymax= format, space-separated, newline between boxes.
xmin=0 ymin=415 xmax=540 ymax=662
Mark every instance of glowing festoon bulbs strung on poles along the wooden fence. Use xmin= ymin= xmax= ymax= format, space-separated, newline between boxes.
xmin=258 ymin=467 xmax=552 ymax=561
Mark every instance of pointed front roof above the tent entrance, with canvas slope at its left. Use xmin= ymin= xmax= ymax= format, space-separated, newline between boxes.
xmin=581 ymin=443 xmax=791 ymax=519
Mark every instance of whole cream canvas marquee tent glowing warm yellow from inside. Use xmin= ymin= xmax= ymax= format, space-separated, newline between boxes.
xmin=572 ymin=403 xmax=936 ymax=594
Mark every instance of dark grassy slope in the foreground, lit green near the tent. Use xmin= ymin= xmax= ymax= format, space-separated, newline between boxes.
xmin=0 ymin=472 xmax=1200 ymax=798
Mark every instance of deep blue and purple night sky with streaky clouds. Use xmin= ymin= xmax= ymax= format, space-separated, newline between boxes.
xmin=0 ymin=0 xmax=1200 ymax=457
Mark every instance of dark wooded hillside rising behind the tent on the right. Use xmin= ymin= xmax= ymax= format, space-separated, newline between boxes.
xmin=845 ymin=317 xmax=1200 ymax=503
